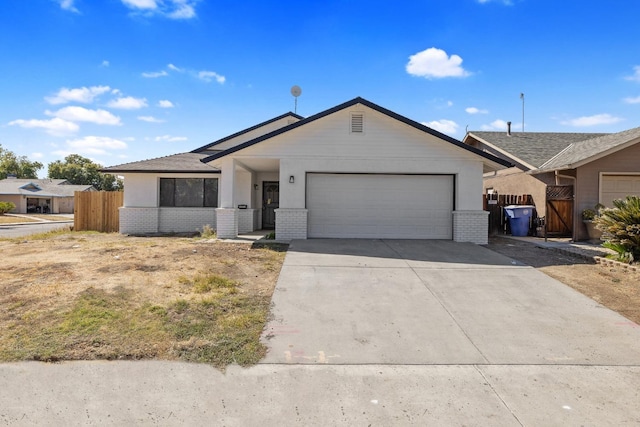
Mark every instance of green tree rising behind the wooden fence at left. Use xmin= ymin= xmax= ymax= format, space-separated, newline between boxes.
xmin=49 ymin=154 xmax=123 ymax=191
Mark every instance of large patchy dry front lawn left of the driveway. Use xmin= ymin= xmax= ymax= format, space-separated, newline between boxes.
xmin=0 ymin=232 xmax=285 ymax=367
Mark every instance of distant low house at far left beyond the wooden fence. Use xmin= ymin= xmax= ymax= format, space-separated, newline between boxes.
xmin=0 ymin=178 xmax=95 ymax=213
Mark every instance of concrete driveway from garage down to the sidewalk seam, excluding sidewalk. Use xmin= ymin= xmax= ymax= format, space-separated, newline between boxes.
xmin=263 ymin=240 xmax=640 ymax=366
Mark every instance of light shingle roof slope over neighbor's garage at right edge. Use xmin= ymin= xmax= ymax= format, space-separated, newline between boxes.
xmin=536 ymin=127 xmax=640 ymax=172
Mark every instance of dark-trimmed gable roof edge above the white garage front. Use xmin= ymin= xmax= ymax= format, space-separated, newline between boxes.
xmin=200 ymin=97 xmax=512 ymax=167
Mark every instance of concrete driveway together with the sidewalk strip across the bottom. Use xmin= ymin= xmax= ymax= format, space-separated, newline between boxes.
xmin=0 ymin=240 xmax=640 ymax=426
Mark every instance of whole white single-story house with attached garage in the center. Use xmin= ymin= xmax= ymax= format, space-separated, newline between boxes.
xmin=103 ymin=98 xmax=511 ymax=244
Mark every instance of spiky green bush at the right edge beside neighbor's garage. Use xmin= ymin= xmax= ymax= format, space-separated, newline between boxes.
xmin=594 ymin=196 xmax=640 ymax=263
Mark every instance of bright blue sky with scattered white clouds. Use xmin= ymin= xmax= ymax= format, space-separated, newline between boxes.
xmin=0 ymin=0 xmax=640 ymax=176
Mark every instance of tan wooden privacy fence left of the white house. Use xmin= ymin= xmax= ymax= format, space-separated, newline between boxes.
xmin=73 ymin=191 xmax=124 ymax=233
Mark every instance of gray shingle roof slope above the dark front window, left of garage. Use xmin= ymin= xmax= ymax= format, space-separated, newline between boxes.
xmin=101 ymin=153 xmax=220 ymax=173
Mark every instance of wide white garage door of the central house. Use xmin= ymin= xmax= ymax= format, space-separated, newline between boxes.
xmin=307 ymin=173 xmax=453 ymax=239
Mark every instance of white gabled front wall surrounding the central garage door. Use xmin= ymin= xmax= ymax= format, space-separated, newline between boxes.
xmin=213 ymin=105 xmax=487 ymax=241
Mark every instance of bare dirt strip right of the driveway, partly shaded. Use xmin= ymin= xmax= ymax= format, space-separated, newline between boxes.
xmin=487 ymin=237 xmax=640 ymax=324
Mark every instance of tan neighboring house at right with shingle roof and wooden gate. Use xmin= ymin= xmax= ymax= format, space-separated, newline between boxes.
xmin=463 ymin=128 xmax=640 ymax=240
